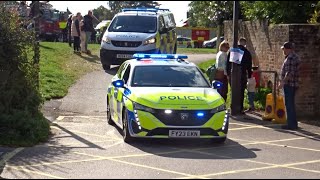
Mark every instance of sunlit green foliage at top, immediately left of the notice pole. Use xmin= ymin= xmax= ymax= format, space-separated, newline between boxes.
xmin=189 ymin=1 xmax=233 ymax=27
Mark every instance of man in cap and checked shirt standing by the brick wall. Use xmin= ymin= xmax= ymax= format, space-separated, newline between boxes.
xmin=278 ymin=42 xmax=300 ymax=130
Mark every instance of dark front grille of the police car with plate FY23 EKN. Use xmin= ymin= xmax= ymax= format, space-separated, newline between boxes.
xmin=153 ymin=109 xmax=214 ymax=126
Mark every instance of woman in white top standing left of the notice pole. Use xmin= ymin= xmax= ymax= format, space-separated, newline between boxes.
xmin=214 ymin=41 xmax=230 ymax=101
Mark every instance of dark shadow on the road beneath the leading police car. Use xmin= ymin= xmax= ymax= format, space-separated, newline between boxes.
xmin=113 ymin=125 xmax=260 ymax=159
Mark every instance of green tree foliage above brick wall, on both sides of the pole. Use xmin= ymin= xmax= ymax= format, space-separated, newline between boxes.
xmin=189 ymin=1 xmax=320 ymax=27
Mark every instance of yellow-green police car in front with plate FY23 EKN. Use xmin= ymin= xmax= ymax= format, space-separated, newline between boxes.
xmin=107 ymin=54 xmax=229 ymax=142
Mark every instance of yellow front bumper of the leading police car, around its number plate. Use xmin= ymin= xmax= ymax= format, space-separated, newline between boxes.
xmin=128 ymin=111 xmax=229 ymax=139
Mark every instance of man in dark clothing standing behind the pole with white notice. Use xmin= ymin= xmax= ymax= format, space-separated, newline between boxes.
xmin=226 ymin=38 xmax=252 ymax=114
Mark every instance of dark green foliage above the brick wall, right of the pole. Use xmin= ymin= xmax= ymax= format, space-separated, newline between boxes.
xmin=241 ymin=1 xmax=318 ymax=24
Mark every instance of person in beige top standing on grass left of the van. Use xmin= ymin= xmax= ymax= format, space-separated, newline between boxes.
xmin=71 ymin=12 xmax=81 ymax=53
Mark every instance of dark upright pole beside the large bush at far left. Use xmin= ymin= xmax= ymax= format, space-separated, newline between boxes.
xmin=32 ymin=1 xmax=40 ymax=89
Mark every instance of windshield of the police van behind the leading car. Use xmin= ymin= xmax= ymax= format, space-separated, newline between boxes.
xmin=108 ymin=16 xmax=157 ymax=33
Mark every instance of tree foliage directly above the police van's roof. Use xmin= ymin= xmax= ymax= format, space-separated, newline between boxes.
xmin=109 ymin=1 xmax=160 ymax=14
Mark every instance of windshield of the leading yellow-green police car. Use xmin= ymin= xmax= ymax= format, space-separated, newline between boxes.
xmin=131 ymin=65 xmax=210 ymax=88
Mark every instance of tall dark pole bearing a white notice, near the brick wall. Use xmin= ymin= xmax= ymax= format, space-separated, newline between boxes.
xmin=231 ymin=1 xmax=241 ymax=115
